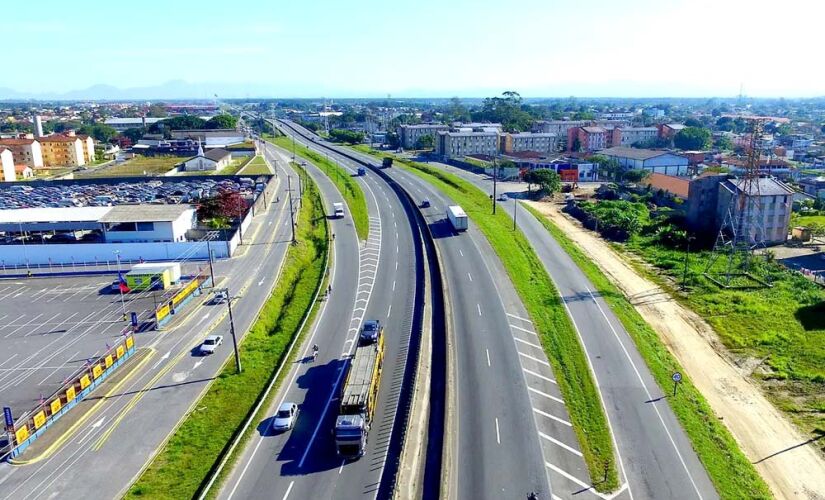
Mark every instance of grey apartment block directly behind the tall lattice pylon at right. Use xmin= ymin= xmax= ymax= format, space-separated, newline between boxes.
xmin=687 ymin=174 xmax=794 ymax=245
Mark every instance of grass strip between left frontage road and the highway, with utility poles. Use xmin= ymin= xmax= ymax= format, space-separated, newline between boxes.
xmin=126 ymin=165 xmax=329 ymax=499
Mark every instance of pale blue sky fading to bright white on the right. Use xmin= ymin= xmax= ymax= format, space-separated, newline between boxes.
xmin=0 ymin=0 xmax=825 ymax=98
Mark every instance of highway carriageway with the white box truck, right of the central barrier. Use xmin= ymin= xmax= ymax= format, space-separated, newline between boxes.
xmin=280 ymin=121 xmax=596 ymax=499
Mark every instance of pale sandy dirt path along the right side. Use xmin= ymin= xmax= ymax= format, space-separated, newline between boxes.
xmin=530 ymin=202 xmax=825 ymax=500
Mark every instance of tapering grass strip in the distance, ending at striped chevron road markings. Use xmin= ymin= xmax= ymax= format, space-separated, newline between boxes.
xmin=264 ymin=134 xmax=370 ymax=240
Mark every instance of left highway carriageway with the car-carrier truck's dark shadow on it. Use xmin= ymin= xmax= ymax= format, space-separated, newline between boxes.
xmin=218 ymin=131 xmax=423 ymax=499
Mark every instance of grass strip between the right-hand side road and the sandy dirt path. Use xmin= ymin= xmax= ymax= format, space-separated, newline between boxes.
xmin=523 ymin=205 xmax=771 ymax=498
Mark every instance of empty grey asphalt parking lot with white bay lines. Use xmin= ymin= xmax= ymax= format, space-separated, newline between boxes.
xmin=0 ymin=274 xmax=159 ymax=418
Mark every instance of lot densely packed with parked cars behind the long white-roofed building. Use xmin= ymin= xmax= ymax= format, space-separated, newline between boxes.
xmin=0 ymin=176 xmax=266 ymax=210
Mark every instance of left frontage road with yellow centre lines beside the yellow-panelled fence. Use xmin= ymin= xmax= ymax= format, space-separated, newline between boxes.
xmin=0 ymin=150 xmax=295 ymax=500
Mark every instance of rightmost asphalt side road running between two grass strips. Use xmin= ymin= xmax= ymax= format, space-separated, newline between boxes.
xmin=428 ymin=158 xmax=718 ymax=499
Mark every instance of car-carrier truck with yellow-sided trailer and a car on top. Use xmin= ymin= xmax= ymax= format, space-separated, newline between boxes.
xmin=335 ymin=326 xmax=384 ymax=459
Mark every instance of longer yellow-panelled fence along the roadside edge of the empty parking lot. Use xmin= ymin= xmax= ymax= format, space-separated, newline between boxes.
xmin=6 ymin=334 xmax=135 ymax=458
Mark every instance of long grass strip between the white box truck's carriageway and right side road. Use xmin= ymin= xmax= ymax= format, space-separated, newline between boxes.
xmin=356 ymin=147 xmax=618 ymax=492
